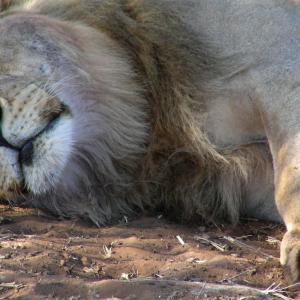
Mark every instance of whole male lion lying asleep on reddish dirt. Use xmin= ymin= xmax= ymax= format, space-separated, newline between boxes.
xmin=0 ymin=0 xmax=300 ymax=280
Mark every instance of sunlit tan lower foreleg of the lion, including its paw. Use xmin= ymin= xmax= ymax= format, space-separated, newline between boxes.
xmin=274 ymin=145 xmax=300 ymax=281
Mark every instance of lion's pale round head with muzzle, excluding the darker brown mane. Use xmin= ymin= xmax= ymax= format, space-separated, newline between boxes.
xmin=0 ymin=13 xmax=148 ymax=223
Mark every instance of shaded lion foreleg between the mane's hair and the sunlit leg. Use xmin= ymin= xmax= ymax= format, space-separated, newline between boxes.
xmin=220 ymin=143 xmax=282 ymax=222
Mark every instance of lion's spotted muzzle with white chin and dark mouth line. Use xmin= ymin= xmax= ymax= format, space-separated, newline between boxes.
xmin=0 ymin=78 xmax=72 ymax=199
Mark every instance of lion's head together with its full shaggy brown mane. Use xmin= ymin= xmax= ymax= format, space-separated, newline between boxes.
xmin=0 ymin=0 xmax=230 ymax=224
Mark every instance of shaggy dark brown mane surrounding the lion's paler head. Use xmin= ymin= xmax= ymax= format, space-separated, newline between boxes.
xmin=3 ymin=0 xmax=272 ymax=225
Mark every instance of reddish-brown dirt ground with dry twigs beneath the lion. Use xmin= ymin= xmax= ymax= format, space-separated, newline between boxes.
xmin=0 ymin=206 xmax=300 ymax=300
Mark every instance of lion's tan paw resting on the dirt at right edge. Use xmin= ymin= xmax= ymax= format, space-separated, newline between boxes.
xmin=280 ymin=231 xmax=300 ymax=282
